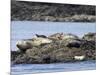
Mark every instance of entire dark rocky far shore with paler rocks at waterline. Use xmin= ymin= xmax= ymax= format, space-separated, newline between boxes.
xmin=11 ymin=0 xmax=96 ymax=22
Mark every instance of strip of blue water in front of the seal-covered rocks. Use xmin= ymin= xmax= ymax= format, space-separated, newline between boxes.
xmin=11 ymin=61 xmax=96 ymax=75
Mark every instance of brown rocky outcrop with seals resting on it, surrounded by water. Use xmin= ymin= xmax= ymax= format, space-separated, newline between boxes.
xmin=11 ymin=33 xmax=96 ymax=64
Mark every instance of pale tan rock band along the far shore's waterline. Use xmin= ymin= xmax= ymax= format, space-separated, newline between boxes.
xmin=12 ymin=15 xmax=96 ymax=23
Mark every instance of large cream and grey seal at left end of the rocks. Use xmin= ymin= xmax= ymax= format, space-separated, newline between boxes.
xmin=16 ymin=37 xmax=52 ymax=51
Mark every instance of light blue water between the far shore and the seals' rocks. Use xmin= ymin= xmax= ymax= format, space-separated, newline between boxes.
xmin=11 ymin=21 xmax=96 ymax=50
